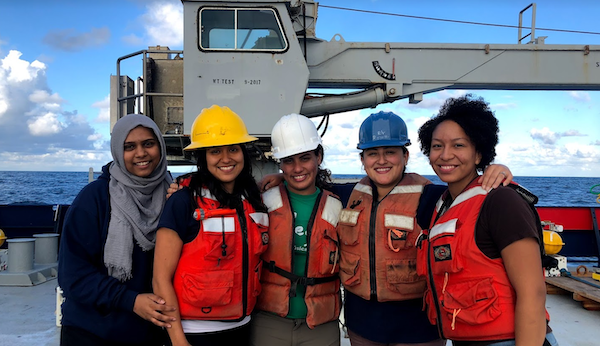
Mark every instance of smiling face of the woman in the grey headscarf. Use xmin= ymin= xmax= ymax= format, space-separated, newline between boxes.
xmin=123 ymin=126 xmax=160 ymax=177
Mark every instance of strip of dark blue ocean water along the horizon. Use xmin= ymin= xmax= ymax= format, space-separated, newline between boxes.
xmin=0 ymin=171 xmax=600 ymax=207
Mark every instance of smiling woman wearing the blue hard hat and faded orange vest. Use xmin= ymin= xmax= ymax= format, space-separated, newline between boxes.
xmin=339 ymin=112 xmax=512 ymax=346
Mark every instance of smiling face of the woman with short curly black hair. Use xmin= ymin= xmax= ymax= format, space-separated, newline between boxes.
xmin=429 ymin=120 xmax=481 ymax=198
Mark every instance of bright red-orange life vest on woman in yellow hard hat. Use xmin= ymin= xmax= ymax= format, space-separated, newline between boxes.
xmin=173 ymin=189 xmax=269 ymax=321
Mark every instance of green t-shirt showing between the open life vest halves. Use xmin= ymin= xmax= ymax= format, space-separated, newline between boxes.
xmin=286 ymin=184 xmax=321 ymax=318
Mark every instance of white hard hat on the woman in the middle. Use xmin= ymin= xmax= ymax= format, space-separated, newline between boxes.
xmin=271 ymin=113 xmax=321 ymax=159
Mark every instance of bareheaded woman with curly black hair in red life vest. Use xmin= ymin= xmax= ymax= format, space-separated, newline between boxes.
xmin=418 ymin=94 xmax=557 ymax=346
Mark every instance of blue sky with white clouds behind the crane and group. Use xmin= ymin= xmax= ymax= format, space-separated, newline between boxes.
xmin=0 ymin=0 xmax=600 ymax=177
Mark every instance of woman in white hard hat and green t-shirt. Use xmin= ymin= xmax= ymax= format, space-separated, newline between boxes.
xmin=251 ymin=114 xmax=342 ymax=346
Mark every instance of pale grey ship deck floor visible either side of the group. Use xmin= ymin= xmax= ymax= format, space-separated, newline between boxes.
xmin=0 ymin=280 xmax=600 ymax=346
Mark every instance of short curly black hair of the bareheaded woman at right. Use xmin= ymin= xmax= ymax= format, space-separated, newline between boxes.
xmin=419 ymin=94 xmax=498 ymax=171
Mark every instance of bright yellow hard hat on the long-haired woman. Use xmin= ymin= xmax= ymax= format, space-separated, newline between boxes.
xmin=183 ymin=105 xmax=258 ymax=150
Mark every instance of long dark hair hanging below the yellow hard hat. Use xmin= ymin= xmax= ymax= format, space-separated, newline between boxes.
xmin=189 ymin=144 xmax=267 ymax=211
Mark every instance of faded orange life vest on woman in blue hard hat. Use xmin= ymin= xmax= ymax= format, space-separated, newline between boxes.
xmin=339 ymin=173 xmax=431 ymax=302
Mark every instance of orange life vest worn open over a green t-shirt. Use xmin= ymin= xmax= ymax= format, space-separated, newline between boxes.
xmin=256 ymin=184 xmax=342 ymax=328
